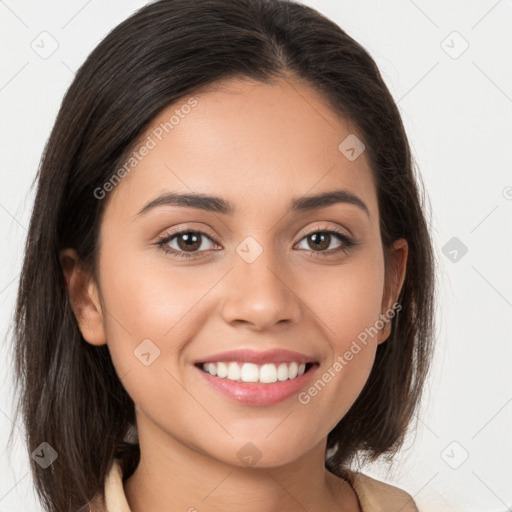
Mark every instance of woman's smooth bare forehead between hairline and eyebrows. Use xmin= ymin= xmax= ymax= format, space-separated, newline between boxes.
xmin=105 ymin=78 xmax=376 ymax=221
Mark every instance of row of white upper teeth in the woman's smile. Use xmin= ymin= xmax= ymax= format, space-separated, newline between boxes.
xmin=203 ymin=361 xmax=306 ymax=383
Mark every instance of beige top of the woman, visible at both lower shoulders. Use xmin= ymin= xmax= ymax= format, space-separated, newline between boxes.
xmin=90 ymin=460 xmax=418 ymax=512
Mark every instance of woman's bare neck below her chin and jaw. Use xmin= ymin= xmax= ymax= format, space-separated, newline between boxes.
xmin=124 ymin=414 xmax=360 ymax=512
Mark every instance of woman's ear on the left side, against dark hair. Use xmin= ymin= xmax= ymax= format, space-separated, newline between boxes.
xmin=59 ymin=249 xmax=107 ymax=345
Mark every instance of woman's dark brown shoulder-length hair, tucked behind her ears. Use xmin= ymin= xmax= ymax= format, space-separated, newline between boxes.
xmin=11 ymin=0 xmax=435 ymax=512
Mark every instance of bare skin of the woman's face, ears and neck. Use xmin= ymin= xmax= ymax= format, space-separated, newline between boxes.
xmin=61 ymin=78 xmax=407 ymax=512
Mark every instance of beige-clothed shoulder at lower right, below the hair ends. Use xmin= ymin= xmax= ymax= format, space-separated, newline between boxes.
xmin=344 ymin=471 xmax=418 ymax=512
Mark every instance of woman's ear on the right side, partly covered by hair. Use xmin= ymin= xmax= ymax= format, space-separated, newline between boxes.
xmin=377 ymin=238 xmax=409 ymax=343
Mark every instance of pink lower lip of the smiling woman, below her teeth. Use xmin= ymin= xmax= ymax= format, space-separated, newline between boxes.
xmin=195 ymin=364 xmax=318 ymax=405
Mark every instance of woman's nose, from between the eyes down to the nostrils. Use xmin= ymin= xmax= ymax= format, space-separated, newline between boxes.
xmin=223 ymin=236 xmax=300 ymax=328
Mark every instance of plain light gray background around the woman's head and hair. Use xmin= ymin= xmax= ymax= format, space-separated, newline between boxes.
xmin=0 ymin=0 xmax=512 ymax=512
